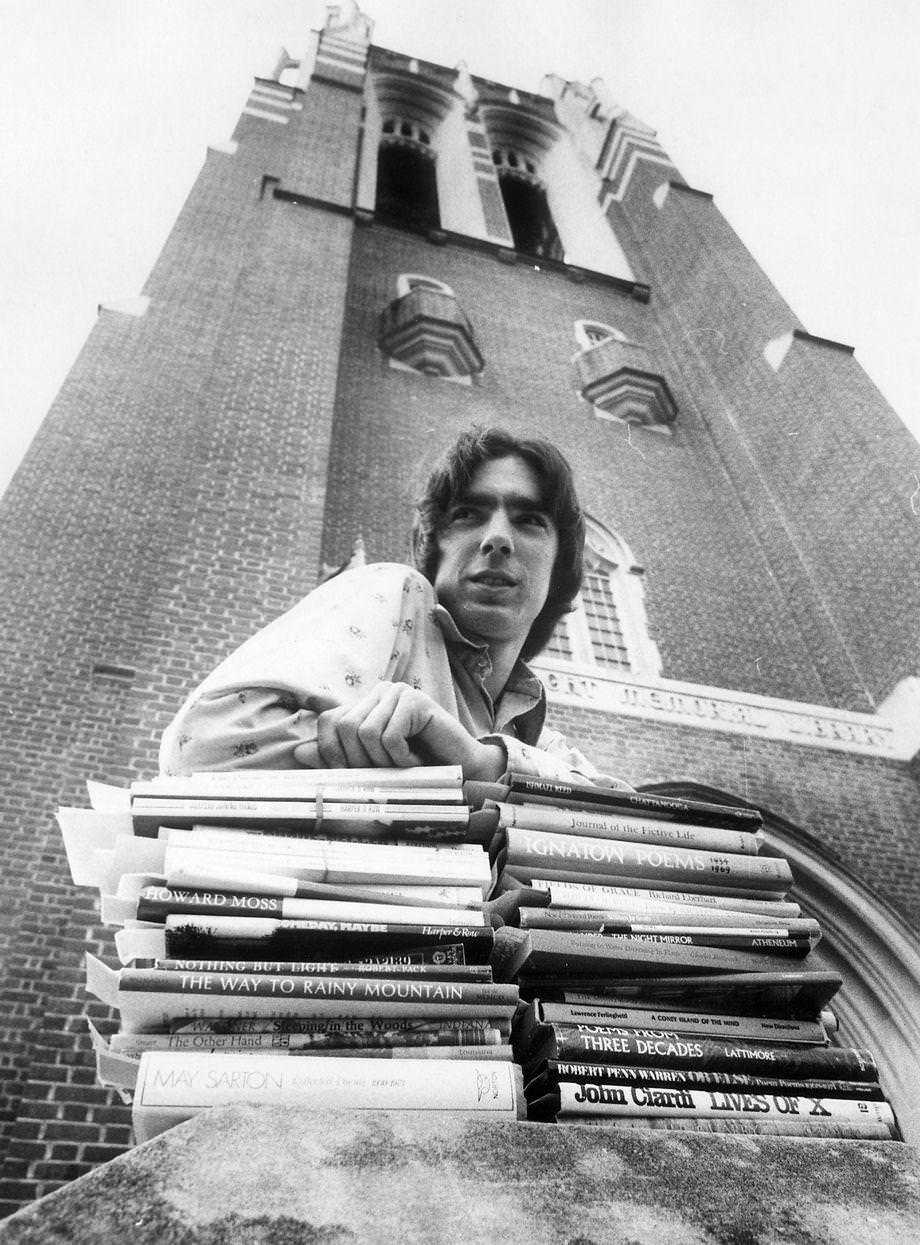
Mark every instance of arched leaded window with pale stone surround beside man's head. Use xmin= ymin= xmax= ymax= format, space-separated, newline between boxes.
xmin=545 ymin=517 xmax=661 ymax=676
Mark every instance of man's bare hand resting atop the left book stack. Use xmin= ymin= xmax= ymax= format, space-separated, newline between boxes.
xmin=294 ymin=682 xmax=507 ymax=782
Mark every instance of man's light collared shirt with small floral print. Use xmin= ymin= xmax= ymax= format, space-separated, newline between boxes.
xmin=161 ymin=563 xmax=610 ymax=781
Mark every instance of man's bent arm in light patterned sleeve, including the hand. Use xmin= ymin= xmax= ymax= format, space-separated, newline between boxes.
xmin=161 ymin=563 xmax=505 ymax=778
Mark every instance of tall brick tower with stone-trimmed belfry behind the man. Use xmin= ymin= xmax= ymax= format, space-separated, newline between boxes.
xmin=0 ymin=5 xmax=920 ymax=1209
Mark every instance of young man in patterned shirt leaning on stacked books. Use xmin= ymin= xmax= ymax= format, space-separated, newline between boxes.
xmin=161 ymin=428 xmax=624 ymax=783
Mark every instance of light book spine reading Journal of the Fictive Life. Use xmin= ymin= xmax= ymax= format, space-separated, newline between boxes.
xmin=495 ymin=803 xmax=761 ymax=855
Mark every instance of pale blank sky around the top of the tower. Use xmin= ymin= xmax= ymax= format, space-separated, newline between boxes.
xmin=0 ymin=0 xmax=920 ymax=491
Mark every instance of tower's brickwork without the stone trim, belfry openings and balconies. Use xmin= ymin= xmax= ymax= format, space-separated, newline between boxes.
xmin=0 ymin=31 xmax=920 ymax=1225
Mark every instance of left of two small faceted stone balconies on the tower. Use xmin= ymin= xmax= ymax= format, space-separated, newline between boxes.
xmin=377 ymin=289 xmax=486 ymax=378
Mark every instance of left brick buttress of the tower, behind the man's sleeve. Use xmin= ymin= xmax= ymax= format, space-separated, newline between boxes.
xmin=0 ymin=14 xmax=364 ymax=1209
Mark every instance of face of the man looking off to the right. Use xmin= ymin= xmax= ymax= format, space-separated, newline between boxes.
xmin=434 ymin=454 xmax=559 ymax=649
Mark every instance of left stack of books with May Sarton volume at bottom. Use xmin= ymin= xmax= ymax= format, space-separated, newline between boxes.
xmin=59 ymin=767 xmax=524 ymax=1140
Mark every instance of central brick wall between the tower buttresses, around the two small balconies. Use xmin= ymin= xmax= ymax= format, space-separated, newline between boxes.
xmin=324 ymin=225 xmax=830 ymax=702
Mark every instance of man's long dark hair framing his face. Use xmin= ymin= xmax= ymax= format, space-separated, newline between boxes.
xmin=412 ymin=428 xmax=585 ymax=661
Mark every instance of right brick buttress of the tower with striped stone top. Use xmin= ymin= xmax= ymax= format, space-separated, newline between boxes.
xmin=596 ymin=117 xmax=920 ymax=711
